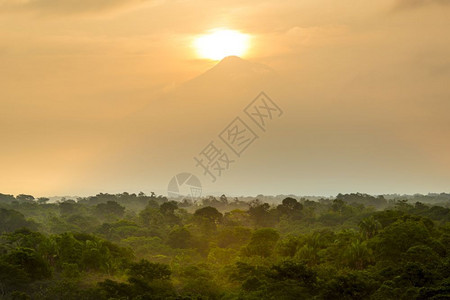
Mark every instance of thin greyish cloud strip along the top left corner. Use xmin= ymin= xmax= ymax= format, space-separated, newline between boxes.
xmin=0 ymin=0 xmax=157 ymax=14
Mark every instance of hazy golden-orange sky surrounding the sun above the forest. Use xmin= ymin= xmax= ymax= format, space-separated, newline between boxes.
xmin=0 ymin=0 xmax=450 ymax=197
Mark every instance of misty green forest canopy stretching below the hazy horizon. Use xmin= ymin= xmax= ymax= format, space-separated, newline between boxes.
xmin=0 ymin=193 xmax=450 ymax=300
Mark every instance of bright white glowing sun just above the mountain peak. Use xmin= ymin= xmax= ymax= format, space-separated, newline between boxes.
xmin=194 ymin=28 xmax=250 ymax=60
